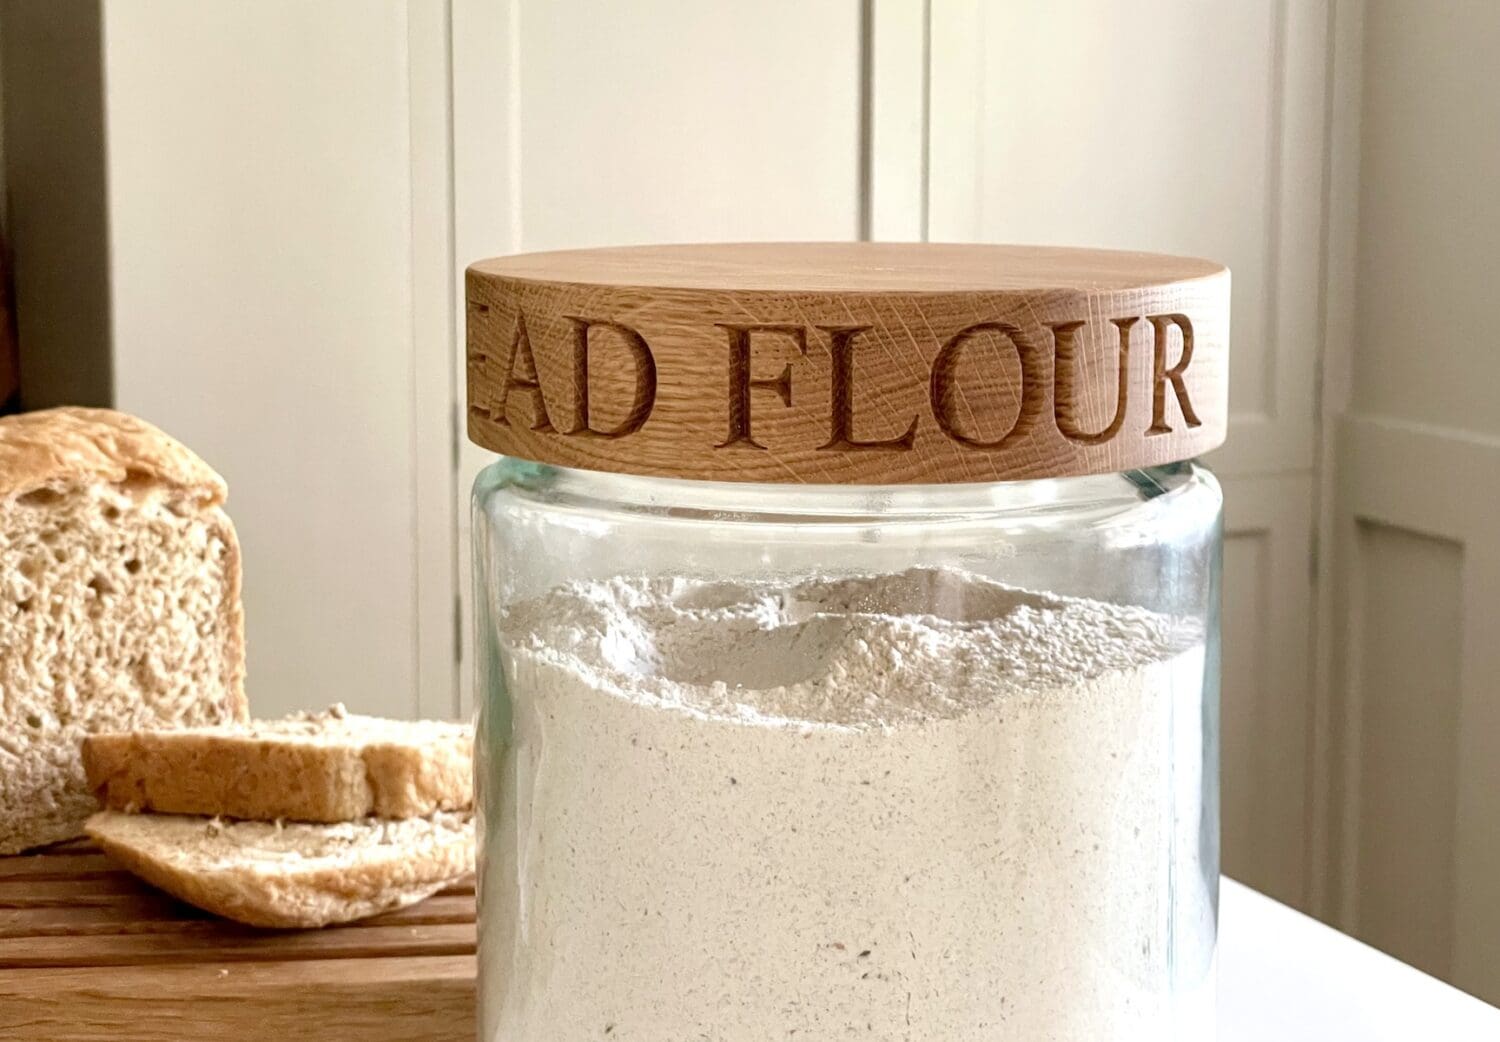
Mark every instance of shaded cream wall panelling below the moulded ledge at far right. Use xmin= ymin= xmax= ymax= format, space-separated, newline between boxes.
xmin=1332 ymin=417 xmax=1500 ymax=1002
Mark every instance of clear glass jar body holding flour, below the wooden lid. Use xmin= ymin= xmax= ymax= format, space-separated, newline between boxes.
xmin=474 ymin=459 xmax=1221 ymax=1042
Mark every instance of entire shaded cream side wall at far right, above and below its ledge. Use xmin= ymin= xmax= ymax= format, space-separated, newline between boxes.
xmin=1322 ymin=0 xmax=1500 ymax=1002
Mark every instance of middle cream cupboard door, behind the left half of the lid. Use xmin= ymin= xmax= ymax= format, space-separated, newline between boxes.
xmin=453 ymin=0 xmax=864 ymax=716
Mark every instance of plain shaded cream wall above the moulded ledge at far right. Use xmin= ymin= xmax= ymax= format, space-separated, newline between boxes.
xmin=1352 ymin=0 xmax=1500 ymax=436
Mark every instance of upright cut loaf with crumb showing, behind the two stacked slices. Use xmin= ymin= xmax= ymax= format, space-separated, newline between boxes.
xmin=0 ymin=409 xmax=246 ymax=855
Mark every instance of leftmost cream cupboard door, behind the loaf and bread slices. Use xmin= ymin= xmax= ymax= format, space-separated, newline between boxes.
xmin=104 ymin=0 xmax=429 ymax=715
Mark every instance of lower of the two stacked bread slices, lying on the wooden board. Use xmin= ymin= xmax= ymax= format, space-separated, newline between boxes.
xmin=87 ymin=811 xmax=474 ymax=928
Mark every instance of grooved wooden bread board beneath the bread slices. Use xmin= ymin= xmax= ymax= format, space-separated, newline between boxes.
xmin=0 ymin=840 xmax=476 ymax=1042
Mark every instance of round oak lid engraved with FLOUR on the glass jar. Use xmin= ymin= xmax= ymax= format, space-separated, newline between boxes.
xmin=467 ymin=243 xmax=1229 ymax=484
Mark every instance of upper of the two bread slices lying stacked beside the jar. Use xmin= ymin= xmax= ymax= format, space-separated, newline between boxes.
xmin=84 ymin=706 xmax=474 ymax=822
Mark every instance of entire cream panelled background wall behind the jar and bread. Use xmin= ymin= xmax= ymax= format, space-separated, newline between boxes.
xmin=0 ymin=0 xmax=1500 ymax=1000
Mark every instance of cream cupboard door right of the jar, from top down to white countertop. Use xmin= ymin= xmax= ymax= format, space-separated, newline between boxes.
xmin=927 ymin=0 xmax=1328 ymax=907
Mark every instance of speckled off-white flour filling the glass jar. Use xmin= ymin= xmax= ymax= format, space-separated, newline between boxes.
xmin=482 ymin=570 xmax=1211 ymax=1042
